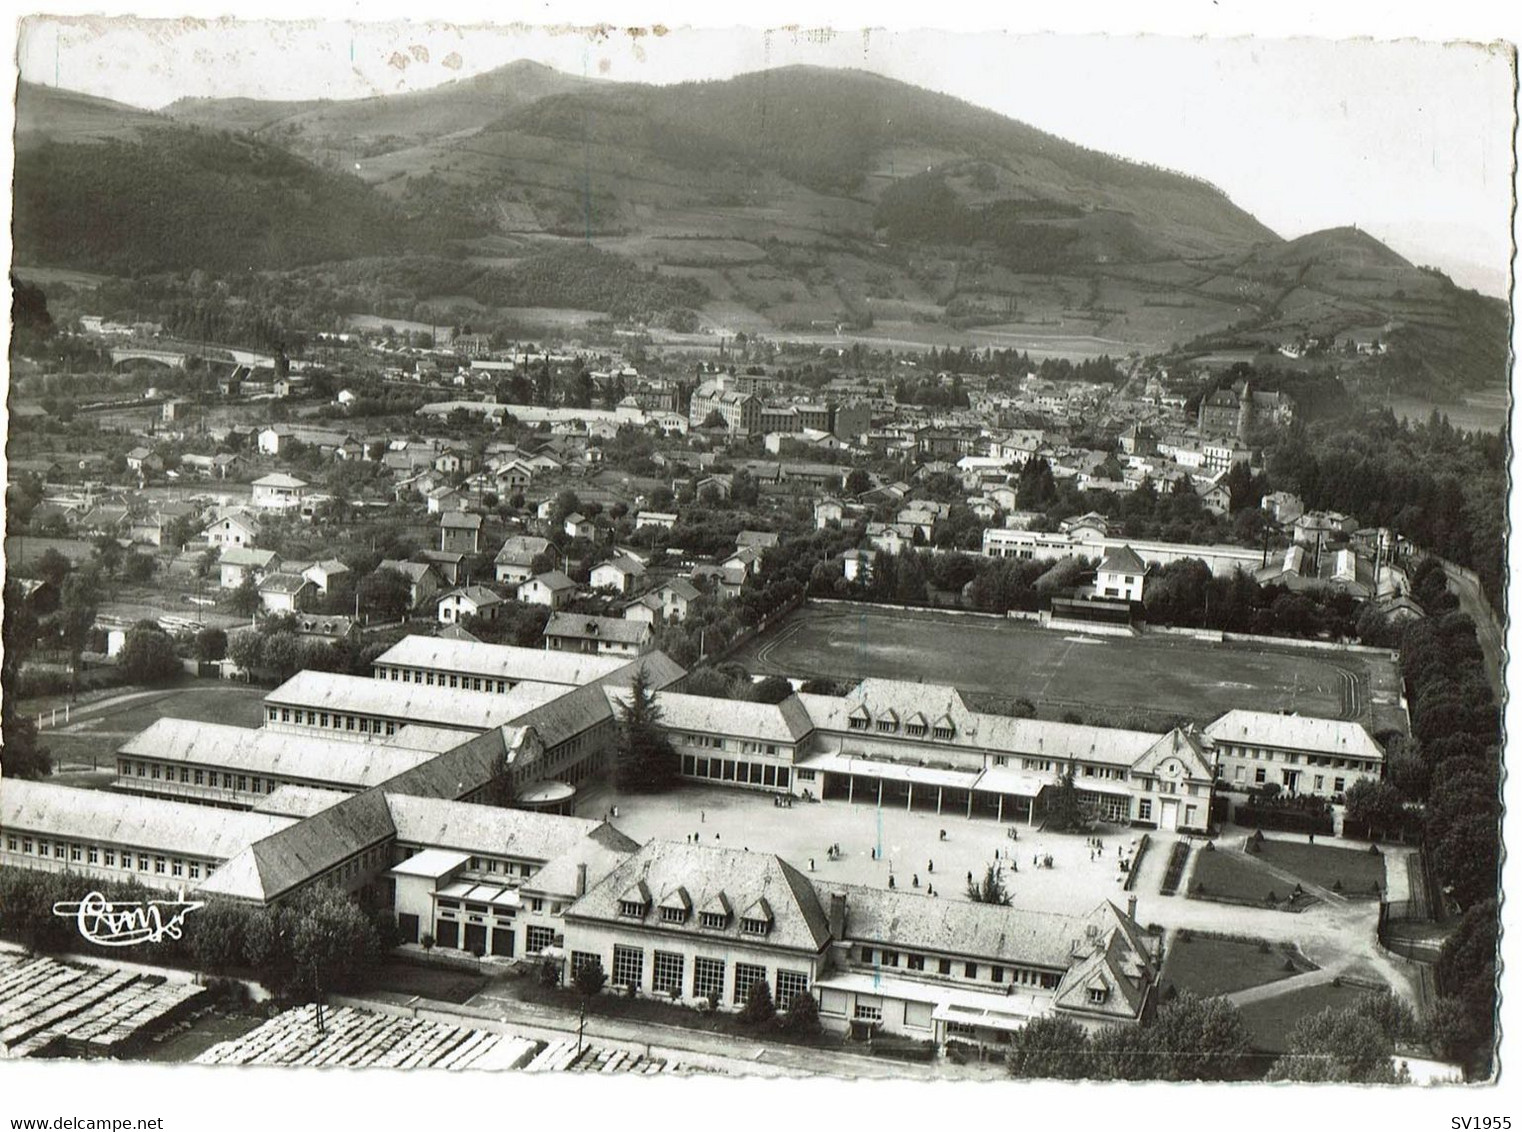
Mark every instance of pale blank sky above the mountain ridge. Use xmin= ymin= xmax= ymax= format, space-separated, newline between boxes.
xmin=18 ymin=12 xmax=1516 ymax=295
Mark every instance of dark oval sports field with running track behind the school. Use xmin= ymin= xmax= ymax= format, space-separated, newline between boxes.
xmin=732 ymin=606 xmax=1393 ymax=723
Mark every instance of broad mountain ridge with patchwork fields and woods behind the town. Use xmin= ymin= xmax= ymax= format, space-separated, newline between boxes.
xmin=17 ymin=61 xmax=1505 ymax=398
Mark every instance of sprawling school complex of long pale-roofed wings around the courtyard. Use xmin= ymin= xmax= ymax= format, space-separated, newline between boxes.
xmin=0 ymin=638 xmax=1383 ymax=1044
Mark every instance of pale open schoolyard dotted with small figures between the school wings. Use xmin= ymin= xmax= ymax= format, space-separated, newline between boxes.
xmin=577 ymin=785 xmax=1157 ymax=913
